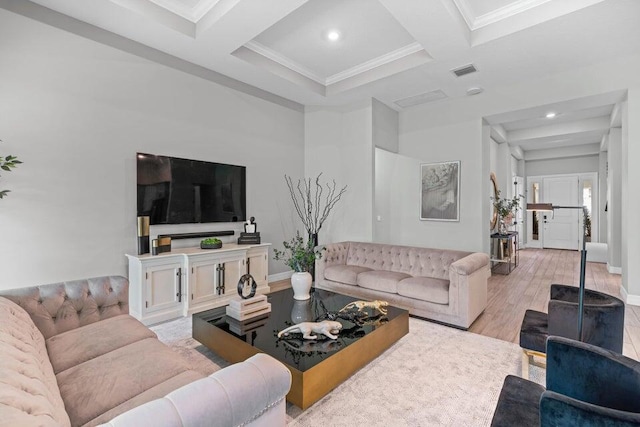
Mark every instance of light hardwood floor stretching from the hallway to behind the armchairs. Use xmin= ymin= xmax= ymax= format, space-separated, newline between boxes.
xmin=270 ymin=249 xmax=640 ymax=360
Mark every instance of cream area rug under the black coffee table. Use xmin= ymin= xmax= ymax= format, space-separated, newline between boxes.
xmin=151 ymin=317 xmax=545 ymax=427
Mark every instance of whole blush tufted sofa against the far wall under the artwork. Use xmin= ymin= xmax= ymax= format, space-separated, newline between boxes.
xmin=315 ymin=242 xmax=491 ymax=329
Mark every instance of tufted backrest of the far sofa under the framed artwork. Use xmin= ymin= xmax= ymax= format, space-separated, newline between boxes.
xmin=346 ymin=242 xmax=471 ymax=280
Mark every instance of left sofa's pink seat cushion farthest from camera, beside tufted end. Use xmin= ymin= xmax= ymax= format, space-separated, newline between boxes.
xmin=46 ymin=314 xmax=156 ymax=374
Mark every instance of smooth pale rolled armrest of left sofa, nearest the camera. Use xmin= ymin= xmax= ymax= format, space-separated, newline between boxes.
xmin=103 ymin=353 xmax=291 ymax=427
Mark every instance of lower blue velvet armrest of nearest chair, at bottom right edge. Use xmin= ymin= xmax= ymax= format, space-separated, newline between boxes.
xmin=540 ymin=390 xmax=640 ymax=427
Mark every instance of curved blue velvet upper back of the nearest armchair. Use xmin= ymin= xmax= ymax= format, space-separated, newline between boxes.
xmin=547 ymin=336 xmax=640 ymax=412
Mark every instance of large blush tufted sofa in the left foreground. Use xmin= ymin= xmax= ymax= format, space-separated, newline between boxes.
xmin=0 ymin=276 xmax=291 ymax=427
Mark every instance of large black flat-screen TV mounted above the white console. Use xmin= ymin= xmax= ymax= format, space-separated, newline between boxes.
xmin=137 ymin=153 xmax=246 ymax=224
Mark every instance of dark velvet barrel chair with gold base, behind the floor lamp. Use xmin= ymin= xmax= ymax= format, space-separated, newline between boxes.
xmin=520 ymin=284 xmax=624 ymax=378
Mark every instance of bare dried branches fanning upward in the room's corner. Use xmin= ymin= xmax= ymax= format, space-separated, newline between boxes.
xmin=284 ymin=173 xmax=347 ymax=246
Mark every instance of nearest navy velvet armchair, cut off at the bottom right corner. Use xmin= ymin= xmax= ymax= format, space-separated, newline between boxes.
xmin=491 ymin=337 xmax=640 ymax=427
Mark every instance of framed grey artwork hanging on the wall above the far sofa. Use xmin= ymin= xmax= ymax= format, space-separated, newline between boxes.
xmin=420 ymin=160 xmax=460 ymax=221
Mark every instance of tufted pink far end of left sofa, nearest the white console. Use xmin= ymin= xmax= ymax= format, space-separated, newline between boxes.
xmin=0 ymin=276 xmax=129 ymax=339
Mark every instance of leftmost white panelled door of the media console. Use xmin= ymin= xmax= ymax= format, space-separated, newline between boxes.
xmin=144 ymin=262 xmax=182 ymax=317
